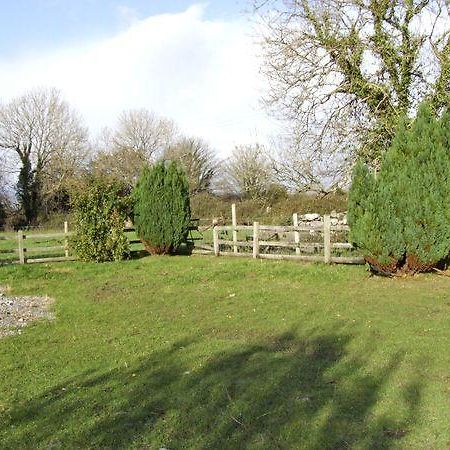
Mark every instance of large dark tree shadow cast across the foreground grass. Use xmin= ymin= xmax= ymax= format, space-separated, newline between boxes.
xmin=0 ymin=332 xmax=421 ymax=449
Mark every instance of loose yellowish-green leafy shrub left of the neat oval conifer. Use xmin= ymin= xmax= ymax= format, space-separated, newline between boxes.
xmin=71 ymin=179 xmax=130 ymax=262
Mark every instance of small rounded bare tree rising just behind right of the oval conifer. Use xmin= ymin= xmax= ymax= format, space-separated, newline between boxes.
xmin=164 ymin=138 xmax=217 ymax=194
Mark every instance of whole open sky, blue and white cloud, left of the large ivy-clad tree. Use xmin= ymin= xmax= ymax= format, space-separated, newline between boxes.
xmin=0 ymin=0 xmax=278 ymax=155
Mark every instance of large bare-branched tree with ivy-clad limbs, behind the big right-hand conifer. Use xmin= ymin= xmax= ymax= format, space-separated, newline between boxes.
xmin=257 ymin=0 xmax=450 ymax=183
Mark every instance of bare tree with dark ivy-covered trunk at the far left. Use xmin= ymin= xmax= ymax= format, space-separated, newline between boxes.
xmin=0 ymin=89 xmax=87 ymax=222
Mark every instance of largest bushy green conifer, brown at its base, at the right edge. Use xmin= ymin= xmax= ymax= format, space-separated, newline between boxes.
xmin=348 ymin=104 xmax=450 ymax=275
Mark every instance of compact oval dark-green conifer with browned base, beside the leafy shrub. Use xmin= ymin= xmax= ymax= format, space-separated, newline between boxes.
xmin=133 ymin=162 xmax=191 ymax=254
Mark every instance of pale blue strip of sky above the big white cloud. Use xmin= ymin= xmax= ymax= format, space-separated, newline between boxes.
xmin=0 ymin=0 xmax=249 ymax=58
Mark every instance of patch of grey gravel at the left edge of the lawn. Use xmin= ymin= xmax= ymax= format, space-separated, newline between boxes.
xmin=0 ymin=290 xmax=53 ymax=338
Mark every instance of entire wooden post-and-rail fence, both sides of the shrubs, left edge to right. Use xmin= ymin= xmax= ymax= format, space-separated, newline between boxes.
xmin=0 ymin=208 xmax=364 ymax=265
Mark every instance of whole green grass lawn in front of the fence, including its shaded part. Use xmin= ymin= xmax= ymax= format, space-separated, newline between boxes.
xmin=0 ymin=257 xmax=450 ymax=450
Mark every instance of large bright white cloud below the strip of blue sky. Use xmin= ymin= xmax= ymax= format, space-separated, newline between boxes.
xmin=0 ymin=6 xmax=276 ymax=153
